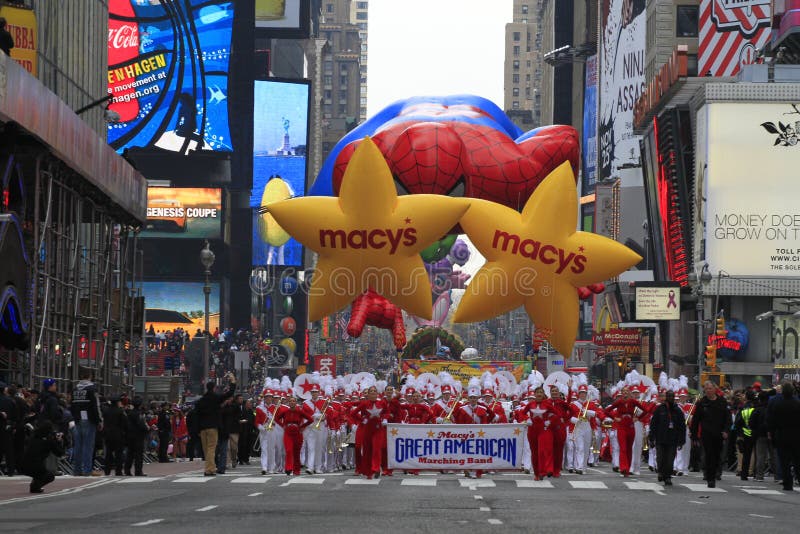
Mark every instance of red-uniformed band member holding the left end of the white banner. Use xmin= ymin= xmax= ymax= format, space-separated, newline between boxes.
xmin=351 ymin=386 xmax=387 ymax=479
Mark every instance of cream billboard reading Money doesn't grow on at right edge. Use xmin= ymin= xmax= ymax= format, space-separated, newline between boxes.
xmin=699 ymin=103 xmax=800 ymax=277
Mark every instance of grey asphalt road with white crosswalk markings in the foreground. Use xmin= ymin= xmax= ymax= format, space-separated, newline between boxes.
xmin=0 ymin=462 xmax=800 ymax=534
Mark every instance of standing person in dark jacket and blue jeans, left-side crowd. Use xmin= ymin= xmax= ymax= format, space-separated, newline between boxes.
xmin=71 ymin=369 xmax=103 ymax=476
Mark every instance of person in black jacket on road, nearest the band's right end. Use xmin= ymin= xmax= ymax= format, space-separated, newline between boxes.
xmin=650 ymin=391 xmax=686 ymax=486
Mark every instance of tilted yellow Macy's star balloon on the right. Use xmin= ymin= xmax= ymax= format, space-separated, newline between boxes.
xmin=453 ymin=162 xmax=642 ymax=358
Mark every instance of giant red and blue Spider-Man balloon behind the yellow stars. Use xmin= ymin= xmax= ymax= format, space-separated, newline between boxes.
xmin=309 ymin=95 xmax=588 ymax=348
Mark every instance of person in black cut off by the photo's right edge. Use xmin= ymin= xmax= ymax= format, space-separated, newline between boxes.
xmin=767 ymin=381 xmax=800 ymax=491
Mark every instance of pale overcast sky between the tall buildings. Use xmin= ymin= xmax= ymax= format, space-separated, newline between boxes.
xmin=367 ymin=0 xmax=512 ymax=116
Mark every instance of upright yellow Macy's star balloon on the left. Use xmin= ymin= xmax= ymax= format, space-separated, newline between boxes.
xmin=266 ymin=137 xmax=469 ymax=321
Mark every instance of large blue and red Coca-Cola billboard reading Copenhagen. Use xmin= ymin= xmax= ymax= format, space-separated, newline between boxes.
xmin=108 ymin=0 xmax=233 ymax=154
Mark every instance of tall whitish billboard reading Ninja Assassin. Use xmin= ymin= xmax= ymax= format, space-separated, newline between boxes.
xmin=597 ymin=0 xmax=647 ymax=180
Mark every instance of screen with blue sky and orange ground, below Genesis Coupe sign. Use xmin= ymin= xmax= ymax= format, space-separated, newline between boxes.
xmin=142 ymin=281 xmax=220 ymax=334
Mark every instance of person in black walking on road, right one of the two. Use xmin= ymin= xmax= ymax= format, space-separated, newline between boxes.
xmin=691 ymin=380 xmax=731 ymax=488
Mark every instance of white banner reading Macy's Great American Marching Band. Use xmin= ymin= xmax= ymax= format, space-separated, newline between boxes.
xmin=386 ymin=423 xmax=526 ymax=470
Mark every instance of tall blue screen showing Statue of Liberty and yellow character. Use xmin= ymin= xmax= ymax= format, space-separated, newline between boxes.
xmin=250 ymin=80 xmax=310 ymax=267
